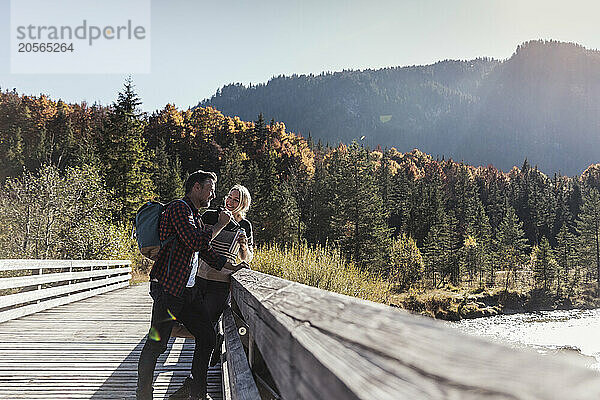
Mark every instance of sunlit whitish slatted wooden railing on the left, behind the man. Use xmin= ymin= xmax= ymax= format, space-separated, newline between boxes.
xmin=0 ymin=260 xmax=131 ymax=322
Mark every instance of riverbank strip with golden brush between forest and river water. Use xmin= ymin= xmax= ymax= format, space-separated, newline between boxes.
xmin=390 ymin=286 xmax=600 ymax=321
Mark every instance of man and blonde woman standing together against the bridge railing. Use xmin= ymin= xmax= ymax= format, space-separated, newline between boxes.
xmin=136 ymin=171 xmax=252 ymax=400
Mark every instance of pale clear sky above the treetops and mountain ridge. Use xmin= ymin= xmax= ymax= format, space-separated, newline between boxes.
xmin=0 ymin=0 xmax=600 ymax=111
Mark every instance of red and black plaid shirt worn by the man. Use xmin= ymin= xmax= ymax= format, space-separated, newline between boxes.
xmin=150 ymin=197 xmax=226 ymax=297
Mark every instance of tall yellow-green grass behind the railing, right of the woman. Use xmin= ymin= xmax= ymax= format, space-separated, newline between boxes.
xmin=252 ymin=243 xmax=391 ymax=304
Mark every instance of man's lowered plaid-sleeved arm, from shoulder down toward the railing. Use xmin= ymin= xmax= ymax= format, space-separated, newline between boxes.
xmin=171 ymin=201 xmax=227 ymax=270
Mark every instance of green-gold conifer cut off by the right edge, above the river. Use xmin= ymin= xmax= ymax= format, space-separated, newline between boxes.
xmin=578 ymin=188 xmax=600 ymax=292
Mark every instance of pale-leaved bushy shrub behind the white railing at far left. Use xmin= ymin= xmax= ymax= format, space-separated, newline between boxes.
xmin=0 ymin=165 xmax=123 ymax=259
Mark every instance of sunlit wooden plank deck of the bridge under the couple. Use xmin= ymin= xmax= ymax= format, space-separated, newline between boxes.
xmin=0 ymin=283 xmax=222 ymax=400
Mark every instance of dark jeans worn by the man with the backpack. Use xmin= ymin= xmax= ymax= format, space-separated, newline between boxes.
xmin=137 ymin=282 xmax=215 ymax=400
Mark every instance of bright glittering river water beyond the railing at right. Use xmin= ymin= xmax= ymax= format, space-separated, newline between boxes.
xmin=448 ymin=309 xmax=600 ymax=370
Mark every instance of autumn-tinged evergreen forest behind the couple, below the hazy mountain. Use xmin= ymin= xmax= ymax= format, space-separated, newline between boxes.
xmin=0 ymin=79 xmax=600 ymax=300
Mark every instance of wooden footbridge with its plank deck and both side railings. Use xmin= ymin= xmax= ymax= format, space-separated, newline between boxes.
xmin=0 ymin=260 xmax=600 ymax=400
